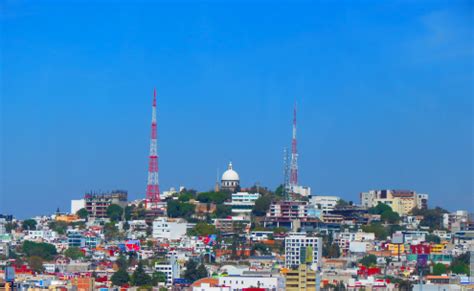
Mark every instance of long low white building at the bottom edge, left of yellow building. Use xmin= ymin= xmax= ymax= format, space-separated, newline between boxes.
xmin=219 ymin=276 xmax=285 ymax=291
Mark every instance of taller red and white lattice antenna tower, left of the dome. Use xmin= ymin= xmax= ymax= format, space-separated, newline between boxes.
xmin=146 ymin=89 xmax=160 ymax=209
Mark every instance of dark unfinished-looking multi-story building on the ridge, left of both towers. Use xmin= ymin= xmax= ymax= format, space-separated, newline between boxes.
xmin=84 ymin=190 xmax=127 ymax=218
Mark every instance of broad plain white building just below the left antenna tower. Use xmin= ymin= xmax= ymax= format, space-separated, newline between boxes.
xmin=152 ymin=217 xmax=188 ymax=240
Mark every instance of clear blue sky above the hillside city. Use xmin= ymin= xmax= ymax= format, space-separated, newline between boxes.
xmin=0 ymin=0 xmax=474 ymax=217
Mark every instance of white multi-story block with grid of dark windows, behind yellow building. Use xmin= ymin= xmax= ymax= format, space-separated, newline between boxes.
xmin=285 ymin=232 xmax=323 ymax=269
